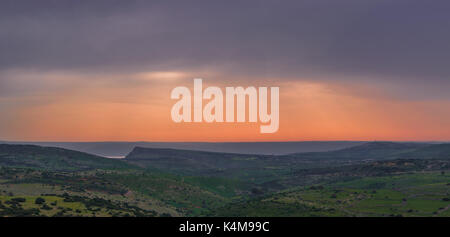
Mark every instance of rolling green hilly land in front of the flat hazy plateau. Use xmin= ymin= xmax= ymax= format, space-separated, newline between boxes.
xmin=0 ymin=142 xmax=450 ymax=217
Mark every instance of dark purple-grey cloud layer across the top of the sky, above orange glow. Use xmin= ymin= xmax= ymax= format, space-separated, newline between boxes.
xmin=0 ymin=0 xmax=450 ymax=85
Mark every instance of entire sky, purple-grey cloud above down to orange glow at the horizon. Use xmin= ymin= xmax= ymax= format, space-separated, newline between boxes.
xmin=0 ymin=0 xmax=450 ymax=141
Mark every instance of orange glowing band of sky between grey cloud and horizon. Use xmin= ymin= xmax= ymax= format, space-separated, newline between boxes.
xmin=0 ymin=72 xmax=450 ymax=142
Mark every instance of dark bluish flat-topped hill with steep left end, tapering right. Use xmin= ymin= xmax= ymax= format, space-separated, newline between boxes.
xmin=124 ymin=147 xmax=308 ymax=180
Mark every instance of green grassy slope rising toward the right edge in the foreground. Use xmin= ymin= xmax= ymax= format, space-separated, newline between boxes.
xmin=215 ymin=172 xmax=450 ymax=217
